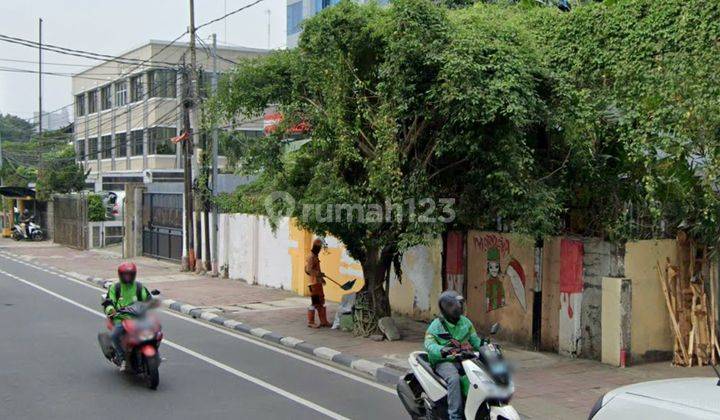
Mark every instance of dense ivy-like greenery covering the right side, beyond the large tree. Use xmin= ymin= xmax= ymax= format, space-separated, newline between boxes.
xmin=529 ymin=0 xmax=720 ymax=243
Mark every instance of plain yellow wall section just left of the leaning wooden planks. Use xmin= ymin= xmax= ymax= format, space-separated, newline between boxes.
xmin=625 ymin=239 xmax=677 ymax=360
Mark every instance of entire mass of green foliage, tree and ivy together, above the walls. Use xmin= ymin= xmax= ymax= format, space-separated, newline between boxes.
xmin=214 ymin=0 xmax=720 ymax=316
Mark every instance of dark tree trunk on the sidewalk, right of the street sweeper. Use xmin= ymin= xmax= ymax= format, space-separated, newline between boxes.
xmin=360 ymin=243 xmax=392 ymax=319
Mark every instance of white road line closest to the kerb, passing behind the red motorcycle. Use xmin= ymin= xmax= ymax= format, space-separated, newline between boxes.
xmin=0 ymin=251 xmax=395 ymax=395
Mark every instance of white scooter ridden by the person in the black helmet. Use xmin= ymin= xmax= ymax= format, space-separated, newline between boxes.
xmin=397 ymin=324 xmax=520 ymax=420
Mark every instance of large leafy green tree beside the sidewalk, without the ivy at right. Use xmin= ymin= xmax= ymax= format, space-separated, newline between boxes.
xmin=215 ymin=0 xmax=563 ymax=315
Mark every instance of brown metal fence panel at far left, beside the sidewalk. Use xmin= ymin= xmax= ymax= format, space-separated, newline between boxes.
xmin=52 ymin=194 xmax=88 ymax=249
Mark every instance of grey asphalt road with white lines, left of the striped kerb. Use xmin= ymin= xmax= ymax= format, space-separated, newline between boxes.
xmin=0 ymin=251 xmax=405 ymax=420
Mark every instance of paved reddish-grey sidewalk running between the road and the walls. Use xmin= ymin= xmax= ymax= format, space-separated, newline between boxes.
xmin=0 ymin=239 xmax=714 ymax=419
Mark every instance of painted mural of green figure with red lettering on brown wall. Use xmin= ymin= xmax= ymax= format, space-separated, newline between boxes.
xmin=473 ymin=234 xmax=527 ymax=312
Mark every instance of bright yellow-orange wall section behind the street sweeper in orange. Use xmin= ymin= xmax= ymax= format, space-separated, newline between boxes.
xmin=288 ymin=221 xmax=365 ymax=302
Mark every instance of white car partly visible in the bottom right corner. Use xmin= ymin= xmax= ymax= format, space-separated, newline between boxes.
xmin=589 ymin=377 xmax=720 ymax=420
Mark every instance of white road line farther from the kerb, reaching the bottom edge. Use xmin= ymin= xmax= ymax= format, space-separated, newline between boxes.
xmin=0 ymin=270 xmax=350 ymax=420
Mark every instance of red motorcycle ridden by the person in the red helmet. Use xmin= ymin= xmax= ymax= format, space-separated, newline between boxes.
xmin=98 ymin=296 xmax=163 ymax=389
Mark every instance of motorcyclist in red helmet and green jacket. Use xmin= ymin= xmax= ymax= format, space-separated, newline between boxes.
xmin=105 ymin=262 xmax=152 ymax=372
